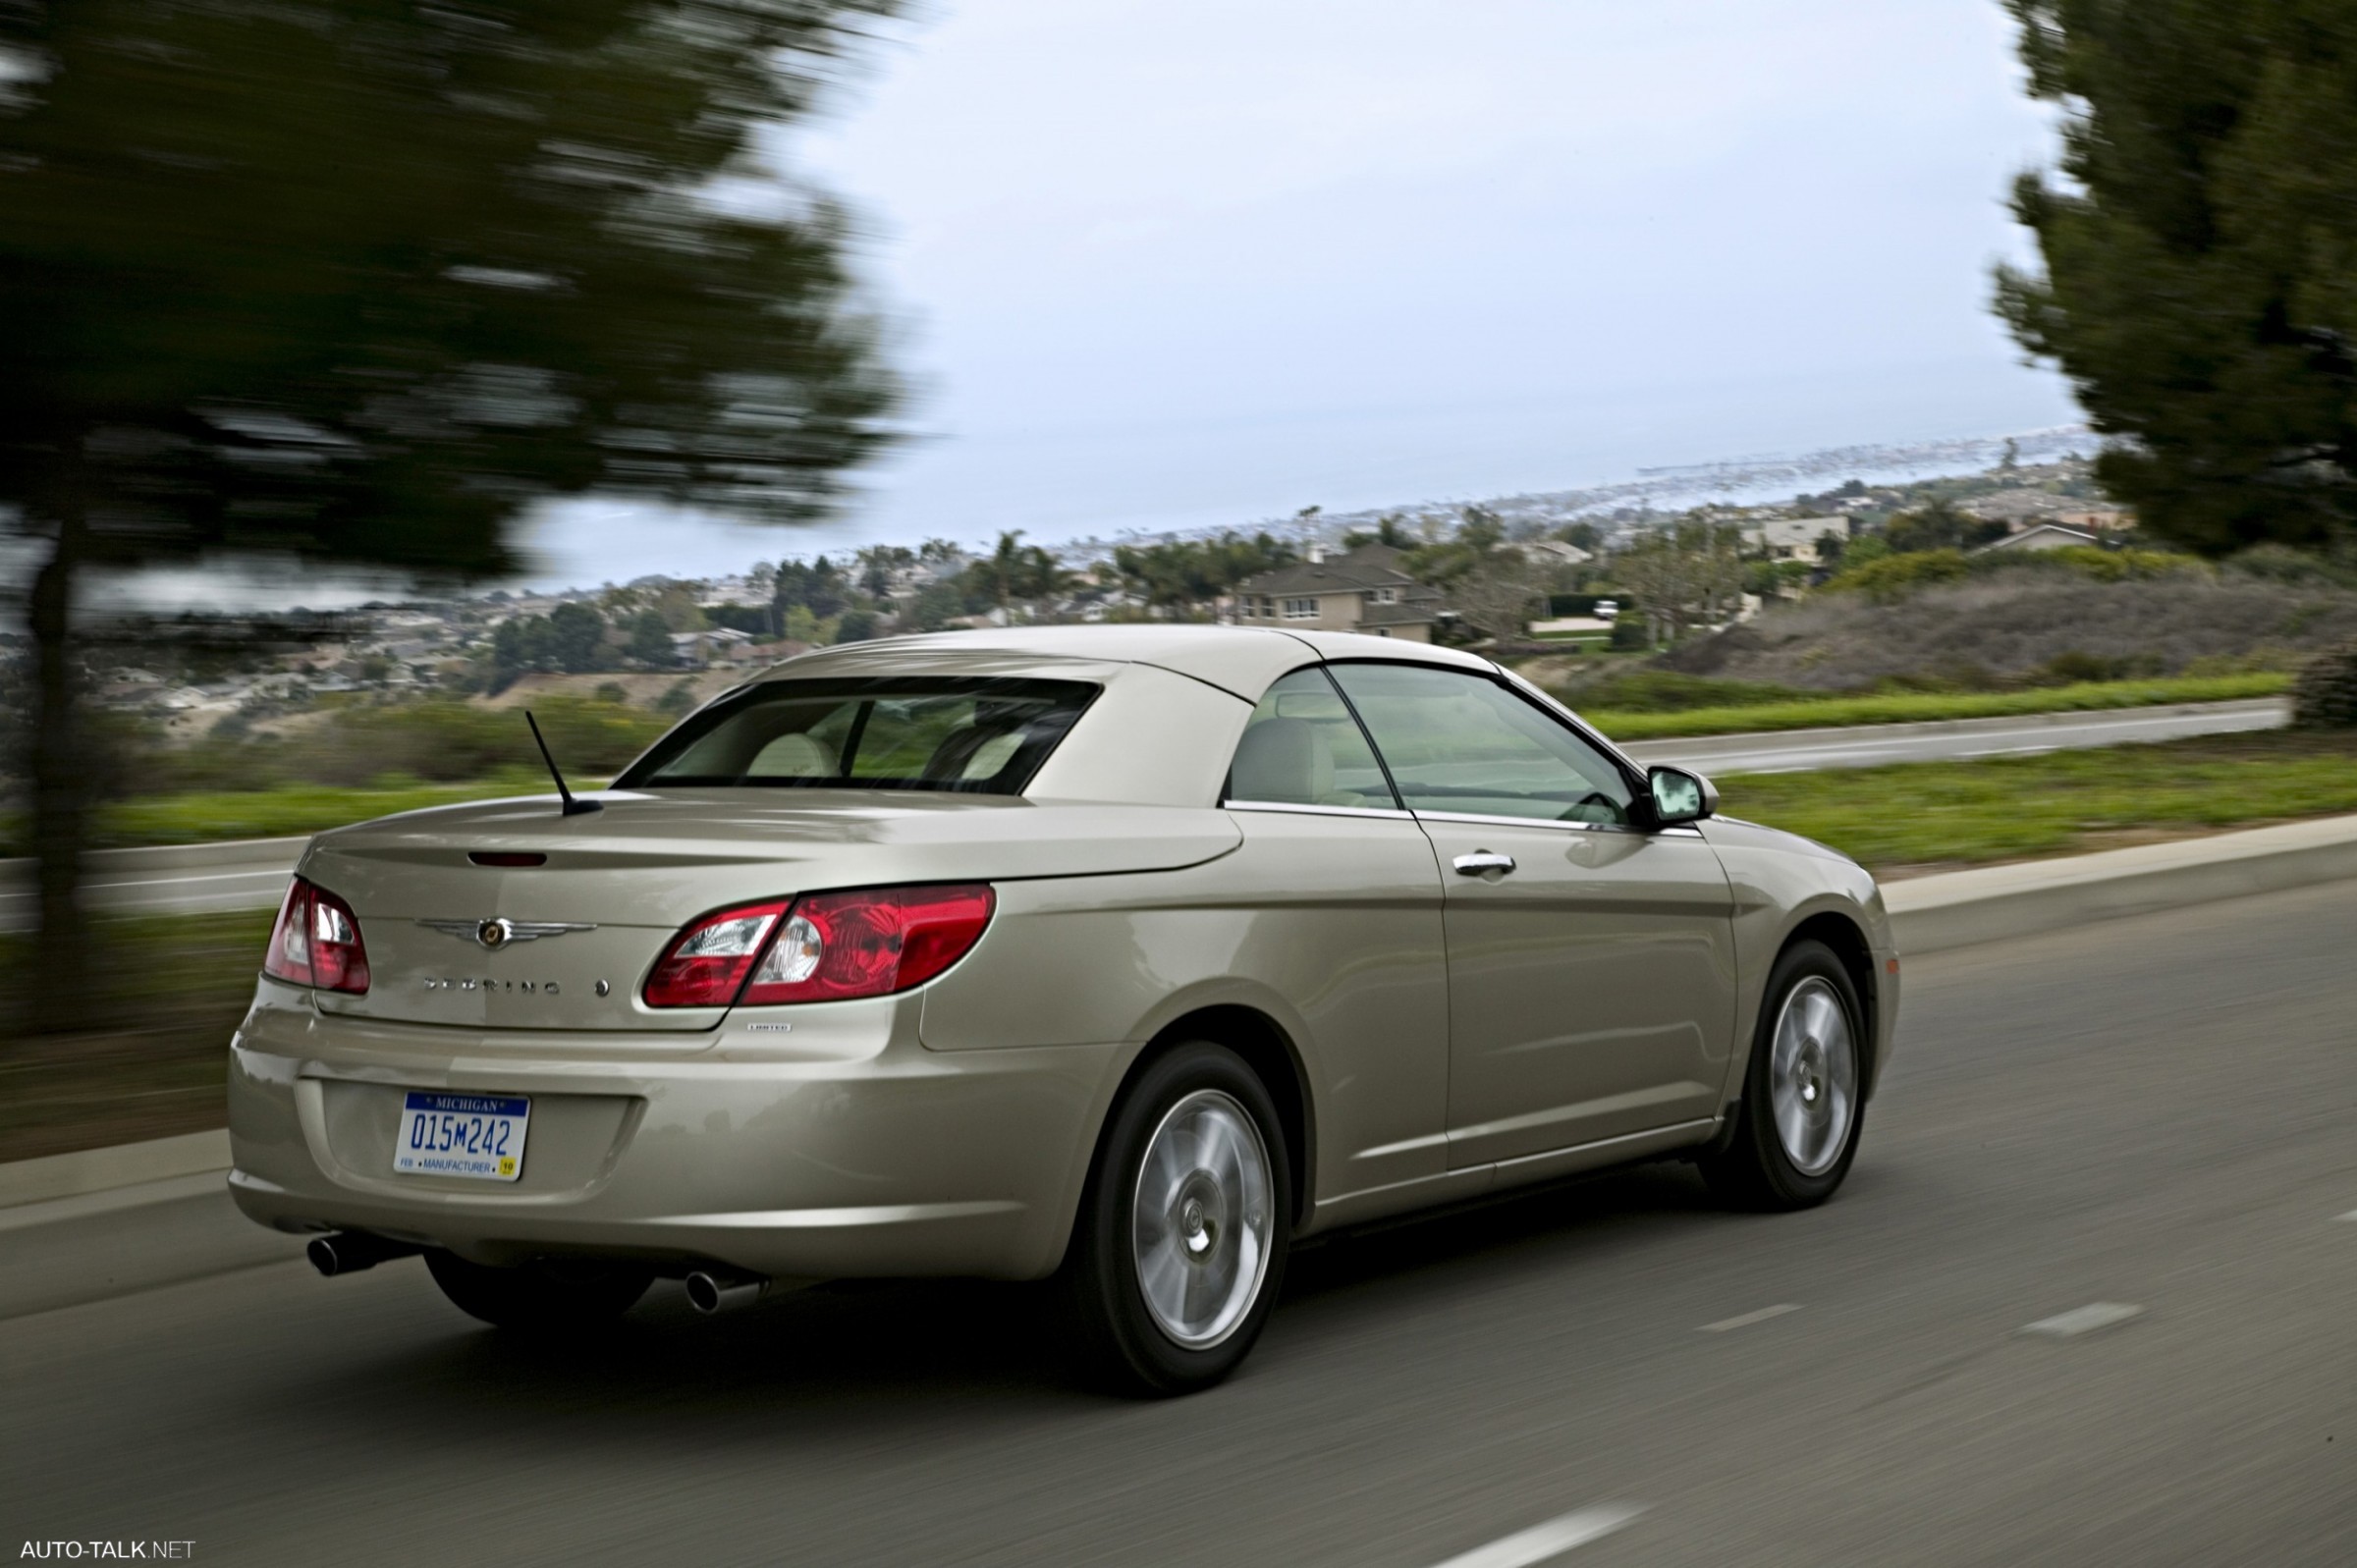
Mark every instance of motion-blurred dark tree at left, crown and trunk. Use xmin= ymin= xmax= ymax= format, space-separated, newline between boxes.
xmin=0 ymin=0 xmax=896 ymax=1026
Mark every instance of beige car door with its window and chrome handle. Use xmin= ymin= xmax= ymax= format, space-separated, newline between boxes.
xmin=1332 ymin=663 xmax=1734 ymax=1167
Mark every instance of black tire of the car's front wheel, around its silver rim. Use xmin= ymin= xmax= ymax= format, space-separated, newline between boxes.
xmin=1699 ymin=941 xmax=1869 ymax=1210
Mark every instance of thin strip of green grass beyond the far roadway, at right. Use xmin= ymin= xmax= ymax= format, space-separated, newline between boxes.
xmin=1569 ymin=672 xmax=2291 ymax=740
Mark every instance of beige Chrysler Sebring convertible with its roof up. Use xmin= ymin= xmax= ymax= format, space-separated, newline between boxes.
xmin=229 ymin=627 xmax=1897 ymax=1393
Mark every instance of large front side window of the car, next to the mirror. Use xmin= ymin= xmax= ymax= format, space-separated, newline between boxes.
xmin=1332 ymin=665 xmax=1633 ymax=826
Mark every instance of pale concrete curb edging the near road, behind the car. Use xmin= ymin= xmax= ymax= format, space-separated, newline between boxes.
xmin=14 ymin=816 xmax=2357 ymax=1318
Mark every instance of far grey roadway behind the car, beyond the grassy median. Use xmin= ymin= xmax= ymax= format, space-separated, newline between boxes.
xmin=0 ymin=700 xmax=2286 ymax=932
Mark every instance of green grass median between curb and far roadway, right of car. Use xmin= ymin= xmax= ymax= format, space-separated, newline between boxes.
xmin=1716 ymin=730 xmax=2357 ymax=870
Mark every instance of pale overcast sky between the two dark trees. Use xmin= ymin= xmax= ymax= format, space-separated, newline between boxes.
xmin=521 ymin=0 xmax=2076 ymax=582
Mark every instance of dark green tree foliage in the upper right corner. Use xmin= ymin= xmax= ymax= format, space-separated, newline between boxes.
xmin=1997 ymin=0 xmax=2357 ymax=557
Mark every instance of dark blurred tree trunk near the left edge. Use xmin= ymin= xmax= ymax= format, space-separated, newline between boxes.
xmin=26 ymin=500 xmax=89 ymax=1035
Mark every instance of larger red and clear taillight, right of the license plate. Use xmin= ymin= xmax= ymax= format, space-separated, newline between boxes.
xmin=646 ymin=882 xmax=995 ymax=1006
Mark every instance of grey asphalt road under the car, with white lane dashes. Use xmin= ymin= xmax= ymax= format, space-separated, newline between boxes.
xmin=0 ymin=885 xmax=2357 ymax=1568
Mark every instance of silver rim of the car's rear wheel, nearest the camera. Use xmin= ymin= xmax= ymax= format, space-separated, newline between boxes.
xmin=1129 ymin=1089 xmax=1273 ymax=1351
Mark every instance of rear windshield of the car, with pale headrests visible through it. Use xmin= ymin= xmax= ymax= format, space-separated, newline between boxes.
xmin=615 ymin=676 xmax=1098 ymax=794
